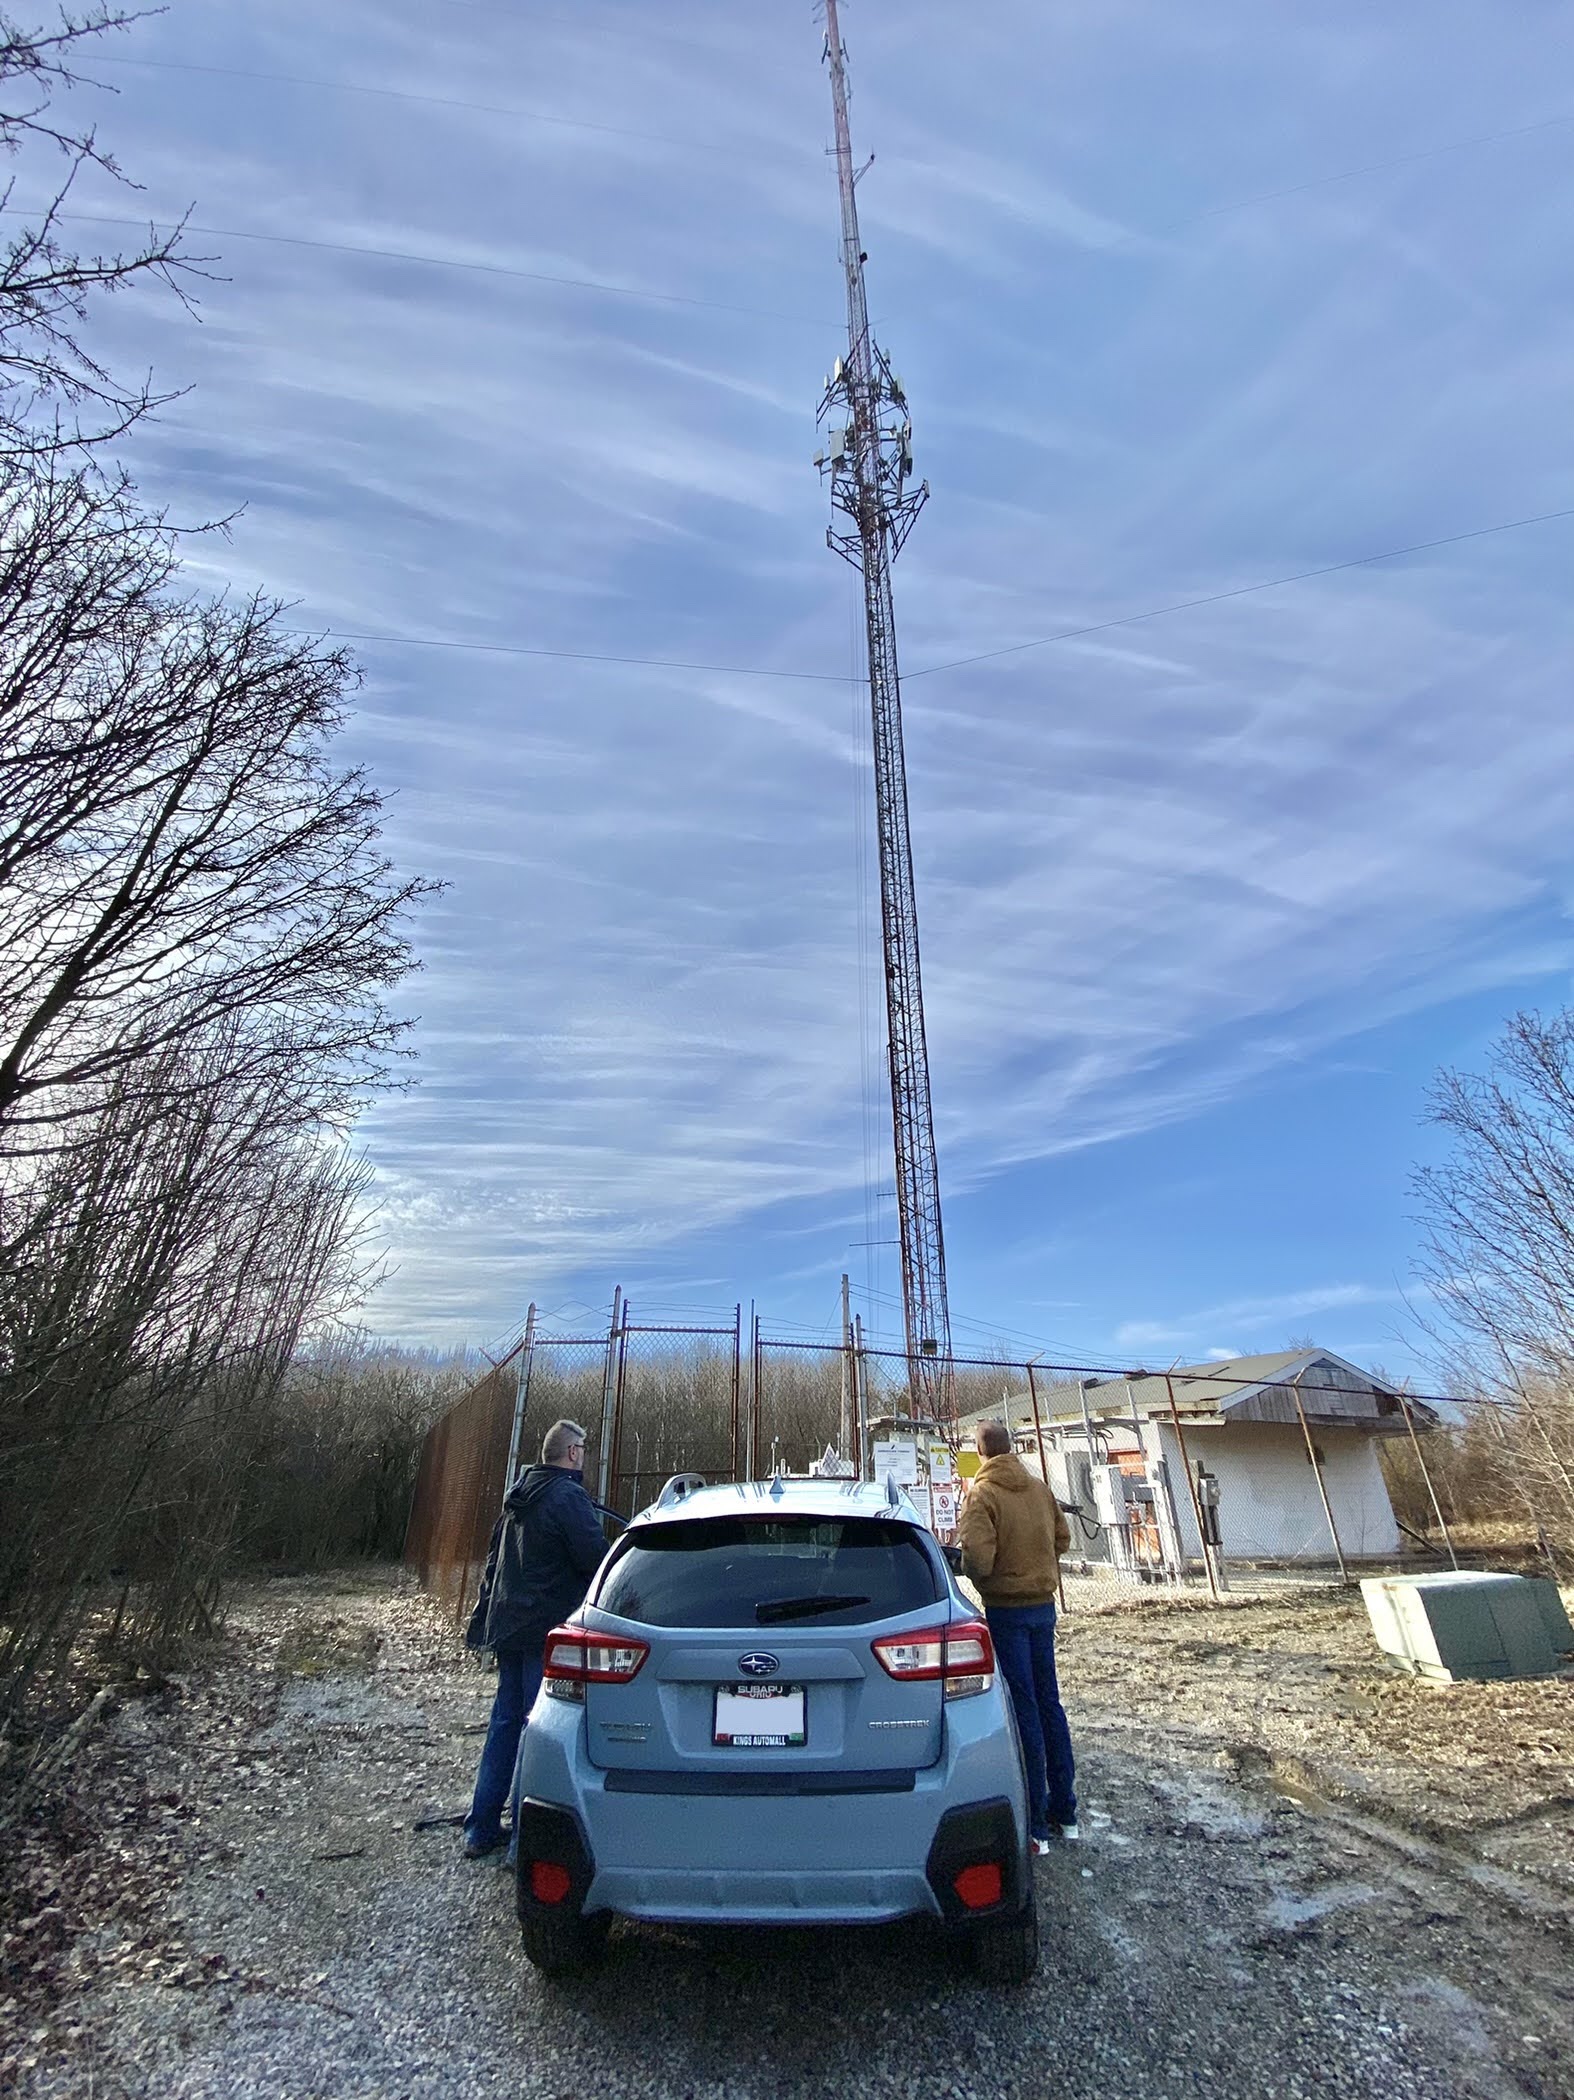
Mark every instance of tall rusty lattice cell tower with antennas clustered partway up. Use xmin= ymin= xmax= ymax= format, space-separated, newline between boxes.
xmin=816 ymin=0 xmax=955 ymax=1422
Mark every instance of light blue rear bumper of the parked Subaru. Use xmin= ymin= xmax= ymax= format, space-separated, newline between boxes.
xmin=520 ymin=1699 xmax=1028 ymax=1926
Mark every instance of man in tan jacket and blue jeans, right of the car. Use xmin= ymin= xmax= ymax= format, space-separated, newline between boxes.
xmin=957 ymin=1422 xmax=1077 ymax=1852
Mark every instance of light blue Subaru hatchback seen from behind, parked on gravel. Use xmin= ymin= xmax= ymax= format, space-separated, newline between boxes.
xmin=518 ymin=1474 xmax=1039 ymax=1982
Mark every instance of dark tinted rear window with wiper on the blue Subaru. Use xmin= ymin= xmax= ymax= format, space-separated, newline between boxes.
xmin=596 ymin=1516 xmax=938 ymax=1630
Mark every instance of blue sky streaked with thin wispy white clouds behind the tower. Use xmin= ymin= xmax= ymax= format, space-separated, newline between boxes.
xmin=36 ymin=0 xmax=1574 ymax=1369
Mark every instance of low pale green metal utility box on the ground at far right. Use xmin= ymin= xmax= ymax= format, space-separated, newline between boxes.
xmin=1360 ymin=1573 xmax=1574 ymax=1684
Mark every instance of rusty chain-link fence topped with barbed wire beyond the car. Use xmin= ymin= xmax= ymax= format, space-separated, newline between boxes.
xmin=405 ymin=1294 xmax=1545 ymax=1617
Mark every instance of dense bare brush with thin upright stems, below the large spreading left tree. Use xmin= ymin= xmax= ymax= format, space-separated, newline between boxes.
xmin=0 ymin=1023 xmax=373 ymax=1701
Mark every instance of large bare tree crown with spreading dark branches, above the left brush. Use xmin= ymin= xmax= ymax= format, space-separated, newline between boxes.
xmin=0 ymin=462 xmax=430 ymax=1149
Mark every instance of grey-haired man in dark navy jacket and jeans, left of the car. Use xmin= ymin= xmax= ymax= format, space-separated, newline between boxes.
xmin=464 ymin=1422 xmax=607 ymax=1859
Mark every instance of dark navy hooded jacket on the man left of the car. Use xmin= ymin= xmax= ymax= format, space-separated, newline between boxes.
xmin=464 ymin=1466 xmax=607 ymax=1649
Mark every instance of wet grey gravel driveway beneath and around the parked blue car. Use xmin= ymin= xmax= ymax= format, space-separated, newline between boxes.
xmin=0 ymin=1573 xmax=1574 ymax=2100
